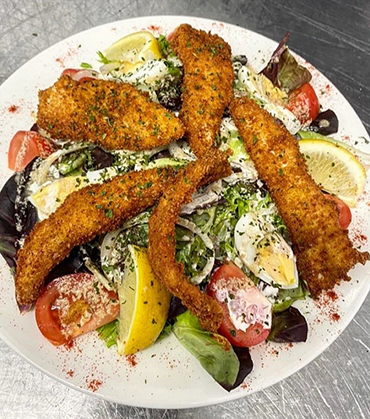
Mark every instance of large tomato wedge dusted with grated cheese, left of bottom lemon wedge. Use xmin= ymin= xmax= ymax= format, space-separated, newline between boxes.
xmin=35 ymin=273 xmax=119 ymax=346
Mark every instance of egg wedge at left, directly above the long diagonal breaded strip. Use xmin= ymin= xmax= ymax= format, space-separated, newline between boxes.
xmin=30 ymin=176 xmax=88 ymax=219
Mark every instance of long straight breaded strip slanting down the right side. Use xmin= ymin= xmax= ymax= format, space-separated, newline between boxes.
xmin=230 ymin=98 xmax=369 ymax=297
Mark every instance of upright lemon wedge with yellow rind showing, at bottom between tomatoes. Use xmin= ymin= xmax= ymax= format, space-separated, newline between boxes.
xmin=117 ymin=245 xmax=171 ymax=355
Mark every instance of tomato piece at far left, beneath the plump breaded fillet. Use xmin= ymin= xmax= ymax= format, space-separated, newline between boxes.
xmin=8 ymin=131 xmax=55 ymax=172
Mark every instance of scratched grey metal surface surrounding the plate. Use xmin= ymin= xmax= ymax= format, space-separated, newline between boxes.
xmin=0 ymin=0 xmax=370 ymax=419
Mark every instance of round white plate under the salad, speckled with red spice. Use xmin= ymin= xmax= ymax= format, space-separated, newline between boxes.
xmin=0 ymin=16 xmax=370 ymax=408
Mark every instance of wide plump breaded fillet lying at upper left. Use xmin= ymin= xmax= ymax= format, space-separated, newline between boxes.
xmin=37 ymin=76 xmax=184 ymax=151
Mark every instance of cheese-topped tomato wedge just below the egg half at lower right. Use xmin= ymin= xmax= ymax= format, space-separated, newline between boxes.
xmin=207 ymin=261 xmax=272 ymax=347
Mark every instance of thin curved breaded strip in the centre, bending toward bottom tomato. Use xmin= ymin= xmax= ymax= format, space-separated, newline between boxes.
xmin=148 ymin=148 xmax=231 ymax=332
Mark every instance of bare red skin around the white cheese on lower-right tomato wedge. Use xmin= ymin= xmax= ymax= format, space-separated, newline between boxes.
xmin=206 ymin=261 xmax=270 ymax=348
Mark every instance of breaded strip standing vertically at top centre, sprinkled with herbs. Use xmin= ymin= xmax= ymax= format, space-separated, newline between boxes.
xmin=170 ymin=24 xmax=234 ymax=157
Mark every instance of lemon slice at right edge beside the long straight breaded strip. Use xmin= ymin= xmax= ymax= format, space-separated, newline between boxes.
xmin=298 ymin=139 xmax=366 ymax=207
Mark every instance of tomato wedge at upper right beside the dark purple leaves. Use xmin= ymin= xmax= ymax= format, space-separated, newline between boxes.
xmin=286 ymin=83 xmax=320 ymax=124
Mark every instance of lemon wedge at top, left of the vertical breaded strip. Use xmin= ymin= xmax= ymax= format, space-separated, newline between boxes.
xmin=104 ymin=31 xmax=162 ymax=74
